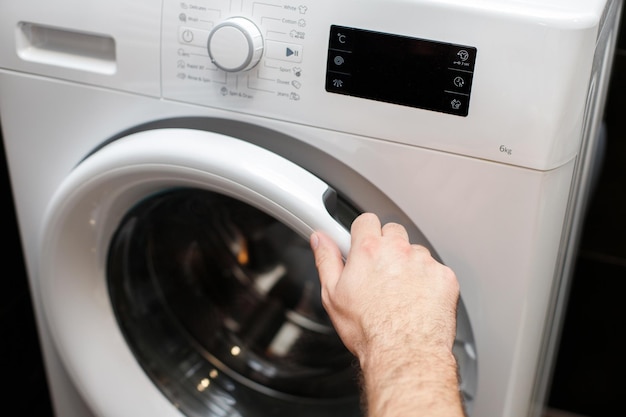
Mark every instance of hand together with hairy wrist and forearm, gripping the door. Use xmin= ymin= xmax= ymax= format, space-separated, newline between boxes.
xmin=311 ymin=214 xmax=465 ymax=417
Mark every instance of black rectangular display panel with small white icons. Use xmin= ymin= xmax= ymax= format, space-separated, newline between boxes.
xmin=326 ymin=25 xmax=477 ymax=116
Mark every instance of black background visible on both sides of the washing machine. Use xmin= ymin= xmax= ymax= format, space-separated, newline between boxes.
xmin=0 ymin=5 xmax=626 ymax=417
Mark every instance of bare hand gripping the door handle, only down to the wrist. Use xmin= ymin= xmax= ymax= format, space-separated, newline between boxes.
xmin=311 ymin=213 xmax=459 ymax=361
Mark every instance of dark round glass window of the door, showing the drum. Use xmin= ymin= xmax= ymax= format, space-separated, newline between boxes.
xmin=107 ymin=189 xmax=359 ymax=416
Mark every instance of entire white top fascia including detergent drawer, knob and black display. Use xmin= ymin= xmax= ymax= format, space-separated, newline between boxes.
xmin=0 ymin=0 xmax=604 ymax=170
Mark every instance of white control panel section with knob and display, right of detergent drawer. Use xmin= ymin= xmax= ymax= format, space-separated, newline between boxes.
xmin=155 ymin=0 xmax=597 ymax=169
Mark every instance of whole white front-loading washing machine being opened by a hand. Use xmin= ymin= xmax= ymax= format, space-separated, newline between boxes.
xmin=0 ymin=0 xmax=621 ymax=417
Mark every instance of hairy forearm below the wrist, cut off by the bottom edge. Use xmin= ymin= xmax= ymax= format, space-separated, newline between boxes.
xmin=361 ymin=344 xmax=465 ymax=417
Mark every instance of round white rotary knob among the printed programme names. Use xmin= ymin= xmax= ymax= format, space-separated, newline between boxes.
xmin=207 ymin=17 xmax=263 ymax=72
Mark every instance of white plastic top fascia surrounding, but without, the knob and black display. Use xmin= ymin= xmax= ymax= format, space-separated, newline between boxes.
xmin=0 ymin=0 xmax=605 ymax=170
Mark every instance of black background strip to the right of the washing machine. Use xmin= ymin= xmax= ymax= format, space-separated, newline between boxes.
xmin=550 ymin=4 xmax=626 ymax=417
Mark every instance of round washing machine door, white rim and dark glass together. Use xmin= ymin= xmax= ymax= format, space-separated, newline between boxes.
xmin=39 ymin=129 xmax=476 ymax=417
